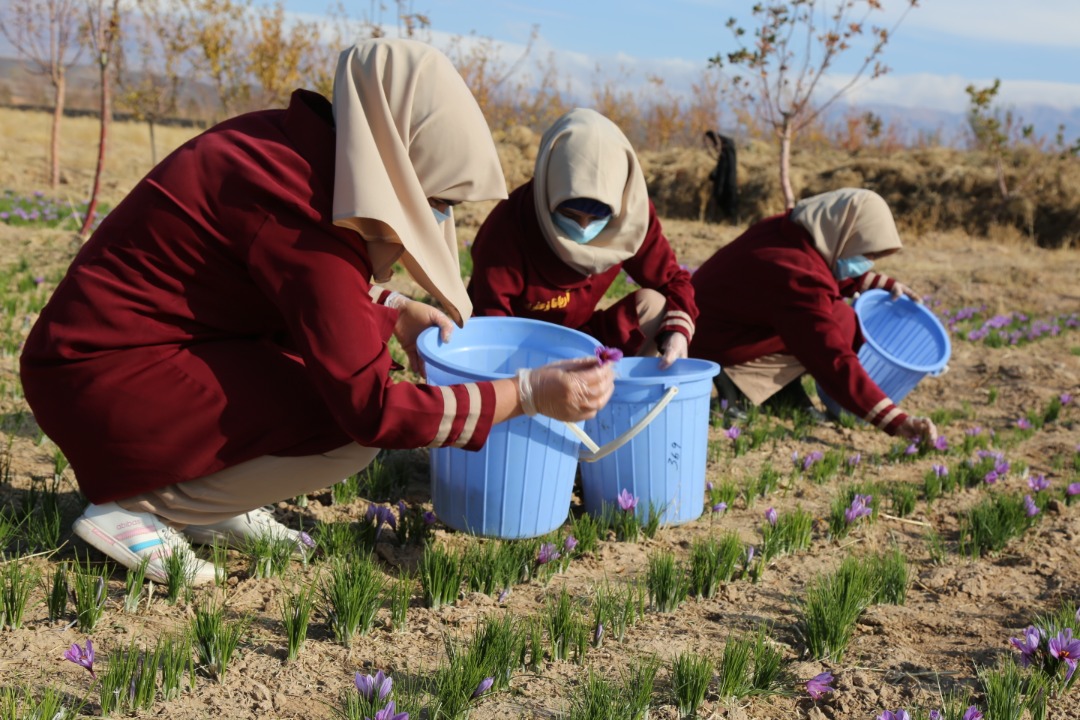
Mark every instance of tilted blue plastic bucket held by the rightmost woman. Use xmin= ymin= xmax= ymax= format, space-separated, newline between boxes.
xmin=818 ymin=289 xmax=953 ymax=416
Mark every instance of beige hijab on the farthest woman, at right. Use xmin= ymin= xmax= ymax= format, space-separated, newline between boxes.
xmin=792 ymin=188 xmax=901 ymax=269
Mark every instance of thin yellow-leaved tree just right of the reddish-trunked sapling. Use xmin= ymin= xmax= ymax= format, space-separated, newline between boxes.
xmin=117 ymin=0 xmax=190 ymax=165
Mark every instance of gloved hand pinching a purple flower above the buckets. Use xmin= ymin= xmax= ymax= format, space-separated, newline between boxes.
xmin=517 ymin=357 xmax=615 ymax=422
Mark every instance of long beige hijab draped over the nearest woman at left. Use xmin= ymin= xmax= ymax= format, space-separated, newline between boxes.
xmin=334 ymin=38 xmax=507 ymax=325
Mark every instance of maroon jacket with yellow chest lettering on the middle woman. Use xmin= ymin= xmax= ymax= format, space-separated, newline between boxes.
xmin=469 ymin=180 xmax=698 ymax=353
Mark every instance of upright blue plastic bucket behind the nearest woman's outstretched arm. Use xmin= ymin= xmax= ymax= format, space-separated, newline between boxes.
xmin=417 ymin=317 xmax=600 ymax=539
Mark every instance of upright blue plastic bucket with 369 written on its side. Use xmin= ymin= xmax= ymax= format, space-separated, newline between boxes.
xmin=581 ymin=357 xmax=720 ymax=525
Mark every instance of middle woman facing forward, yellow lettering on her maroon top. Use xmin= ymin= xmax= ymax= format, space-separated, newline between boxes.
xmin=469 ymin=108 xmax=698 ymax=367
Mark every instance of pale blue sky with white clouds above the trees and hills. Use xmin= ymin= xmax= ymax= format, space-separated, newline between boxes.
xmin=264 ymin=0 xmax=1080 ymax=118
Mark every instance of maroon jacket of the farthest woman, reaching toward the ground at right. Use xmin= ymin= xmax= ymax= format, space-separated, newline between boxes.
xmin=690 ymin=214 xmax=907 ymax=433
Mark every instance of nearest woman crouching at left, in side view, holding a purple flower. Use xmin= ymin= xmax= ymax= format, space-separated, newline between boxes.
xmin=22 ymin=40 xmax=612 ymax=582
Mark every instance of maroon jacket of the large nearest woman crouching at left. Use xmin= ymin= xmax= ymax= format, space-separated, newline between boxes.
xmin=22 ymin=91 xmax=495 ymax=503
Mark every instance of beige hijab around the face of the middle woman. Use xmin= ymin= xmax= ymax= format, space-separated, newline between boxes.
xmin=532 ymin=108 xmax=649 ymax=275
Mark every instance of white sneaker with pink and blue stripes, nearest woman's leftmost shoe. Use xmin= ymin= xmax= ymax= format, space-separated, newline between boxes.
xmin=71 ymin=503 xmax=214 ymax=585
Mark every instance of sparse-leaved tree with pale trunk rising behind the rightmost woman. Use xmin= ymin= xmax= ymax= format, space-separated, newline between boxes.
xmin=710 ymin=0 xmax=918 ymax=207
